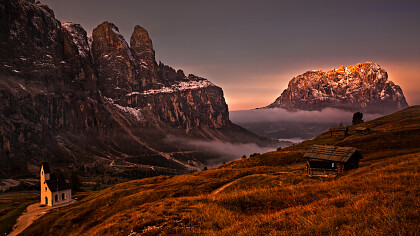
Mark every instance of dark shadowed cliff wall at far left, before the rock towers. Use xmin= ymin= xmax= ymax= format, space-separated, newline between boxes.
xmin=0 ymin=1 xmax=105 ymax=174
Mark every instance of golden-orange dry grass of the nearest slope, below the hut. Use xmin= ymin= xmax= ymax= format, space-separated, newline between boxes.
xmin=25 ymin=154 xmax=420 ymax=235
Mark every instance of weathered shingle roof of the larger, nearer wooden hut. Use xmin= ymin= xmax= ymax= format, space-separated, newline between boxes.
xmin=304 ymin=145 xmax=362 ymax=162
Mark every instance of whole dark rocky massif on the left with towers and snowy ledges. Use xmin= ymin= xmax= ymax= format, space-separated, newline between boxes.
xmin=0 ymin=0 xmax=276 ymax=177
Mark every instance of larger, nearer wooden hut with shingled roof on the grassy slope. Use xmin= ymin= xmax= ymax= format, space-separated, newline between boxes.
xmin=304 ymin=145 xmax=363 ymax=174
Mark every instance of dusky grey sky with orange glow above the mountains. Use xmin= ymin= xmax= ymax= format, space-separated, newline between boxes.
xmin=41 ymin=0 xmax=420 ymax=110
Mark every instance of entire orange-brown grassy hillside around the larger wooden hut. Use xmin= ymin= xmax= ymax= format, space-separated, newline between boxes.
xmin=24 ymin=106 xmax=420 ymax=235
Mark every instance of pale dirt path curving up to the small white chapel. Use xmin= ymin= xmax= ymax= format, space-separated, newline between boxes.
xmin=8 ymin=200 xmax=74 ymax=236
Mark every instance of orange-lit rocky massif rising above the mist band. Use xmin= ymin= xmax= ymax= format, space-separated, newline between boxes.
xmin=266 ymin=62 xmax=408 ymax=113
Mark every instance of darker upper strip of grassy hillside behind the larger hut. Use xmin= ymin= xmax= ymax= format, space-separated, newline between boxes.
xmin=230 ymin=106 xmax=420 ymax=168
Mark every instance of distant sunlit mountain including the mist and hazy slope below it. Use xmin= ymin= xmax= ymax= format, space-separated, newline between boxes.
xmin=231 ymin=62 xmax=408 ymax=140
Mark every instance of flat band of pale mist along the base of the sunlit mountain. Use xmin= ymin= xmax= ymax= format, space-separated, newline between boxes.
xmin=229 ymin=108 xmax=383 ymax=124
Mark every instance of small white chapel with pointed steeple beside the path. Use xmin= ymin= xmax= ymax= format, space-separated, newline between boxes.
xmin=40 ymin=162 xmax=71 ymax=206
